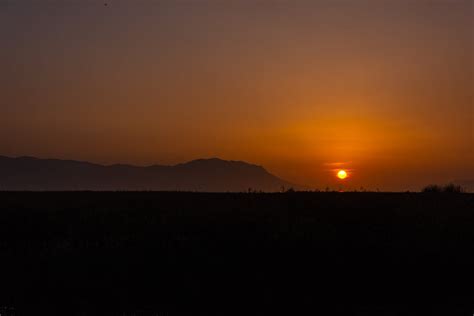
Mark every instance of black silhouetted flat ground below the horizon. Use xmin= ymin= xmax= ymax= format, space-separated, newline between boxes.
xmin=0 ymin=192 xmax=474 ymax=316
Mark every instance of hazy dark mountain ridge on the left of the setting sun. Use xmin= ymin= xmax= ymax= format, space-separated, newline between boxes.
xmin=0 ymin=156 xmax=297 ymax=192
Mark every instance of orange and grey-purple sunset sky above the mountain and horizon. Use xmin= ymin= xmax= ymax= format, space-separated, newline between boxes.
xmin=0 ymin=0 xmax=474 ymax=191
